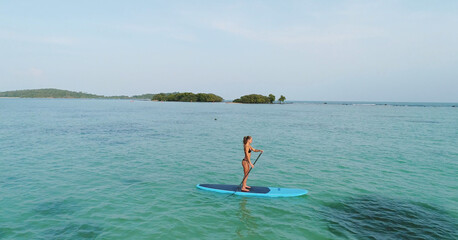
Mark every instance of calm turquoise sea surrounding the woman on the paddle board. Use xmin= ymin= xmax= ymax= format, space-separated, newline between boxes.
xmin=0 ymin=99 xmax=458 ymax=239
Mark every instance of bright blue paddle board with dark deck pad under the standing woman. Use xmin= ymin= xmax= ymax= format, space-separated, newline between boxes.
xmin=196 ymin=184 xmax=308 ymax=197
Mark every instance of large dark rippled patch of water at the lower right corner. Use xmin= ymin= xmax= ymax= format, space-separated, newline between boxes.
xmin=324 ymin=195 xmax=458 ymax=239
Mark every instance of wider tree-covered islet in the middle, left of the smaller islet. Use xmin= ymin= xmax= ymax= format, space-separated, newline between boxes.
xmin=152 ymin=92 xmax=223 ymax=102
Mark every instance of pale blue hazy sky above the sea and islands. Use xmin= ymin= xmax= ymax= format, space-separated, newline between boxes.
xmin=0 ymin=0 xmax=458 ymax=102
